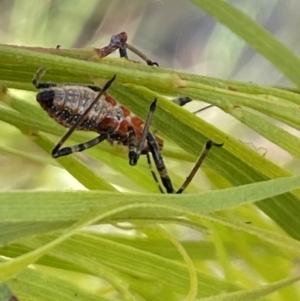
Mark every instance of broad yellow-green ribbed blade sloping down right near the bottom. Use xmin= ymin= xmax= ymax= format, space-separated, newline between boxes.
xmin=10 ymin=234 xmax=237 ymax=297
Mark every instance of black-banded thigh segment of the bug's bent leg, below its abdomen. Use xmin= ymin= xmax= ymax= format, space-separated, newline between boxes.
xmin=52 ymin=129 xmax=114 ymax=158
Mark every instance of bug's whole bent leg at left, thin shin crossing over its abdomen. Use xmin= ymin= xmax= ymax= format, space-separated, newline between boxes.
xmin=52 ymin=75 xmax=116 ymax=158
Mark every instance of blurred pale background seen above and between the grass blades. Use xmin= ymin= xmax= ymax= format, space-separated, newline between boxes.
xmin=0 ymin=0 xmax=300 ymax=189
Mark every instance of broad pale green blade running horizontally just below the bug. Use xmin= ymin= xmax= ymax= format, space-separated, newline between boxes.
xmin=0 ymin=176 xmax=300 ymax=222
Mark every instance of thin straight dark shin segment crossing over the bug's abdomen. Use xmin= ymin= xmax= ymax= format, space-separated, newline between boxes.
xmin=52 ymin=75 xmax=116 ymax=158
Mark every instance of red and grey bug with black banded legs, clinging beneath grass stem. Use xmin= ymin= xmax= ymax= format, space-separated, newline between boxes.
xmin=32 ymin=68 xmax=223 ymax=193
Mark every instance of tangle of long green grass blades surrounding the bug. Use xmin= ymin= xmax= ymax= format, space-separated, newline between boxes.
xmin=0 ymin=0 xmax=300 ymax=300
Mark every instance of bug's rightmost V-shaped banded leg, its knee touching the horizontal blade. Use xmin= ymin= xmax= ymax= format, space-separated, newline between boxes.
xmin=147 ymin=132 xmax=223 ymax=194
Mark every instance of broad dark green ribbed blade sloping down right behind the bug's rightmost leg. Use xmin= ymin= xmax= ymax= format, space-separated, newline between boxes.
xmin=112 ymin=84 xmax=300 ymax=239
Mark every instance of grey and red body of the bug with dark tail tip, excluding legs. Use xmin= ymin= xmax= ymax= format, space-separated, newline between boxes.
xmin=36 ymin=85 xmax=163 ymax=149
